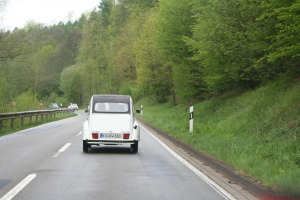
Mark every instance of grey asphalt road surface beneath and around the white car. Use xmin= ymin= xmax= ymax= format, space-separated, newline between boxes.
xmin=0 ymin=112 xmax=234 ymax=200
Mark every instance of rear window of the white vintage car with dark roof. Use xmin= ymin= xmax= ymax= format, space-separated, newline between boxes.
xmin=94 ymin=102 xmax=129 ymax=113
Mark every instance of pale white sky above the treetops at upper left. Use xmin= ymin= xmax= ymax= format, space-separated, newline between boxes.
xmin=0 ymin=0 xmax=101 ymax=30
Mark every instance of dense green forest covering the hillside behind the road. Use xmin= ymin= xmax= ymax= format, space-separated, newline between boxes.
xmin=0 ymin=0 xmax=300 ymax=113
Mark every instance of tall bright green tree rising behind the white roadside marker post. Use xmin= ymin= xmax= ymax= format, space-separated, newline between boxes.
xmin=157 ymin=0 xmax=205 ymax=103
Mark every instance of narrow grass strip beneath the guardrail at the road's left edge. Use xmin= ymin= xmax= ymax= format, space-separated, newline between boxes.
xmin=0 ymin=113 xmax=76 ymax=137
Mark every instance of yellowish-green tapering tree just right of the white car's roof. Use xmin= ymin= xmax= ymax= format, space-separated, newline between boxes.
xmin=135 ymin=10 xmax=172 ymax=102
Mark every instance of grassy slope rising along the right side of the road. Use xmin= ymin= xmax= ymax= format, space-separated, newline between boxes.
xmin=138 ymin=77 xmax=300 ymax=196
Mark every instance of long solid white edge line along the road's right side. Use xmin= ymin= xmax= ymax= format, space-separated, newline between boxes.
xmin=140 ymin=125 xmax=236 ymax=200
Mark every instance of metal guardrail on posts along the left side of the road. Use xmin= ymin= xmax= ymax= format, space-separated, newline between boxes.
xmin=0 ymin=108 xmax=75 ymax=131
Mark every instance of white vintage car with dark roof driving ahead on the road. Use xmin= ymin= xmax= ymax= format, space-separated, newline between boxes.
xmin=82 ymin=95 xmax=140 ymax=153
